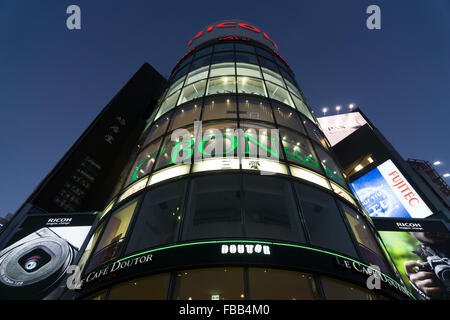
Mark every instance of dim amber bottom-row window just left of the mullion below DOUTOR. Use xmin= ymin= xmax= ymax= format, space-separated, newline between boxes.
xmin=173 ymin=267 xmax=245 ymax=300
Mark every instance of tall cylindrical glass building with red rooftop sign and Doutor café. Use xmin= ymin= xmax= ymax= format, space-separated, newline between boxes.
xmin=75 ymin=21 xmax=409 ymax=300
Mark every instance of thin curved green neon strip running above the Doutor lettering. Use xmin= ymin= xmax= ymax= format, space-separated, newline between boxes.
xmin=94 ymin=240 xmax=416 ymax=300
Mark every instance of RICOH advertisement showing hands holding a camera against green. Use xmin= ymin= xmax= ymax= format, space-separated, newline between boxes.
xmin=373 ymin=218 xmax=450 ymax=300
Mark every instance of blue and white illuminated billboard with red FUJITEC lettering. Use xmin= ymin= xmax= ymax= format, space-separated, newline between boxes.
xmin=350 ymin=160 xmax=433 ymax=218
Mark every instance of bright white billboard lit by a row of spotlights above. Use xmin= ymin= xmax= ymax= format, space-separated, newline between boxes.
xmin=317 ymin=112 xmax=367 ymax=146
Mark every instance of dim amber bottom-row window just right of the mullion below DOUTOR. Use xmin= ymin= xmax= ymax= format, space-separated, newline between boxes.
xmin=248 ymin=268 xmax=320 ymax=300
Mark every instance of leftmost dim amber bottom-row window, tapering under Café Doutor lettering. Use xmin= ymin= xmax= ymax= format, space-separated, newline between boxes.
xmin=108 ymin=273 xmax=170 ymax=300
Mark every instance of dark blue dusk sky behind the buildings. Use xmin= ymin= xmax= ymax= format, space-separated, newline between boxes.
xmin=0 ymin=0 xmax=450 ymax=216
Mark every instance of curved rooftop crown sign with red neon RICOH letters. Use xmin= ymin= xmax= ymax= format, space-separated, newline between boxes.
xmin=188 ymin=21 xmax=278 ymax=50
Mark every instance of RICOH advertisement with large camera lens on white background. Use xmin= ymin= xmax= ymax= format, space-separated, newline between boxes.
xmin=0 ymin=213 xmax=96 ymax=300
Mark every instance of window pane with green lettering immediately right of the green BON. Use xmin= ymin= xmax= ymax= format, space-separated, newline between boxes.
xmin=280 ymin=129 xmax=323 ymax=174
